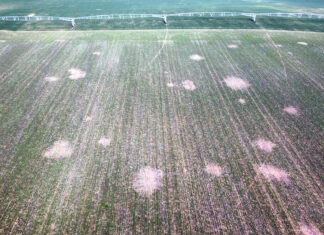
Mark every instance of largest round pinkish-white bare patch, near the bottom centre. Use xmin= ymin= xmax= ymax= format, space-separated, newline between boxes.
xmin=133 ymin=166 xmax=163 ymax=197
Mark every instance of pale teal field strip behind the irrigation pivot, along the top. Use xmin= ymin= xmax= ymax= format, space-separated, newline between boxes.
xmin=0 ymin=0 xmax=324 ymax=16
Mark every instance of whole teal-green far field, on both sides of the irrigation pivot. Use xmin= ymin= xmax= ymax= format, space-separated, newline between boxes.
xmin=0 ymin=0 xmax=324 ymax=32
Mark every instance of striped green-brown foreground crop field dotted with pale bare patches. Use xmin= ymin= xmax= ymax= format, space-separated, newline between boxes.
xmin=0 ymin=30 xmax=324 ymax=234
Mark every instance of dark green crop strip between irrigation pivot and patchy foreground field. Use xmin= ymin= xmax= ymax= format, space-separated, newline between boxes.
xmin=0 ymin=17 xmax=324 ymax=32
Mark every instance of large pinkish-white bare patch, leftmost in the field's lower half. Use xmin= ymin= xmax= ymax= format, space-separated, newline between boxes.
xmin=44 ymin=140 xmax=73 ymax=159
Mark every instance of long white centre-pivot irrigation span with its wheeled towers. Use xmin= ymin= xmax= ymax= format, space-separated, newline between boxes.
xmin=0 ymin=12 xmax=324 ymax=27
